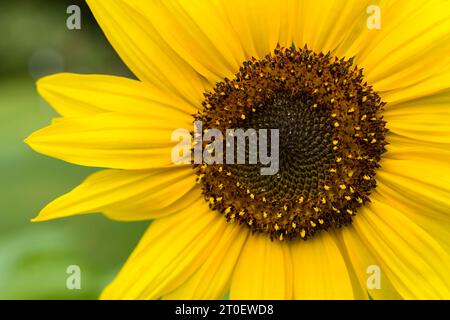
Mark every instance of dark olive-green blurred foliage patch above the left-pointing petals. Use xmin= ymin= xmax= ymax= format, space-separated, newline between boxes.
xmin=0 ymin=0 xmax=131 ymax=77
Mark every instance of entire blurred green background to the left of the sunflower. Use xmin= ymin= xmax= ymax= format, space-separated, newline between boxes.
xmin=0 ymin=0 xmax=148 ymax=299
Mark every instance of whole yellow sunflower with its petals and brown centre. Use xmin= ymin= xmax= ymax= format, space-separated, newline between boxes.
xmin=26 ymin=0 xmax=450 ymax=299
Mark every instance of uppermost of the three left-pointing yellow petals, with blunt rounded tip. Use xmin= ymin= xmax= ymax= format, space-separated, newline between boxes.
xmin=37 ymin=73 xmax=197 ymax=117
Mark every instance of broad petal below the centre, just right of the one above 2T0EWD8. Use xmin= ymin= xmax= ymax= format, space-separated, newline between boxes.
xmin=292 ymin=232 xmax=354 ymax=300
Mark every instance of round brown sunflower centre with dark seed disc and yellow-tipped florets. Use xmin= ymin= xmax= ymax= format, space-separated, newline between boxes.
xmin=194 ymin=46 xmax=387 ymax=240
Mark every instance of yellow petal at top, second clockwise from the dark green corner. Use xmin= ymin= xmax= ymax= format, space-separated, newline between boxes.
xmin=112 ymin=0 xmax=246 ymax=84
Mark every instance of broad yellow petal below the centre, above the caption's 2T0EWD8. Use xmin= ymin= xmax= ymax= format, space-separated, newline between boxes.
xmin=230 ymin=235 xmax=293 ymax=300
